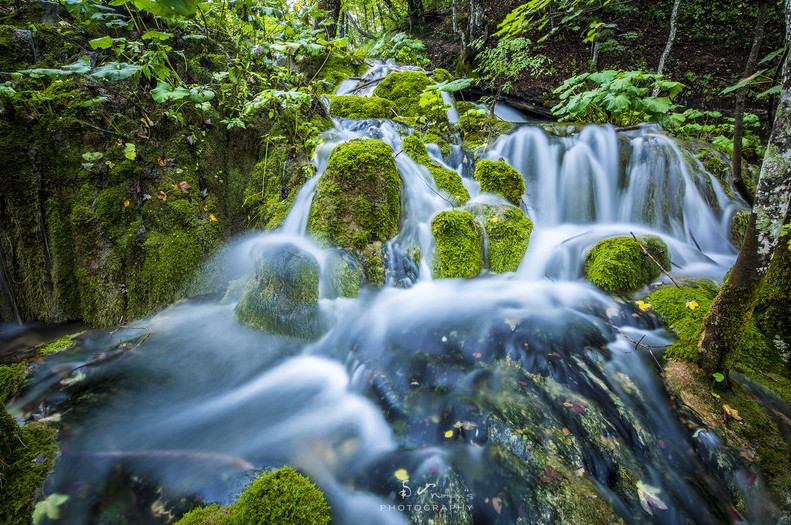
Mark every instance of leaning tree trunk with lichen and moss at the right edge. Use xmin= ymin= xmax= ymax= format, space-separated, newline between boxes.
xmin=699 ymin=26 xmax=791 ymax=374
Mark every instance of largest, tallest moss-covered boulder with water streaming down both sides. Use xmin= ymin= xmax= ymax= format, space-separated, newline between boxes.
xmin=308 ymin=139 xmax=401 ymax=284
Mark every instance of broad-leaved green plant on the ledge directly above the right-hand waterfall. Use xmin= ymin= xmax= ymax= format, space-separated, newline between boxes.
xmin=552 ymin=70 xmax=684 ymax=126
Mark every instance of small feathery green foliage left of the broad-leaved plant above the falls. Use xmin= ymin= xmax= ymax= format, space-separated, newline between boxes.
xmin=475 ymin=37 xmax=550 ymax=93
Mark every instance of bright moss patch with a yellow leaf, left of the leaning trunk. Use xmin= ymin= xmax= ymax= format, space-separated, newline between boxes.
xmin=648 ymin=279 xmax=719 ymax=362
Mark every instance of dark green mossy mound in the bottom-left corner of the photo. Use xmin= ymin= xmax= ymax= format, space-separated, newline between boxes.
xmin=0 ymin=406 xmax=58 ymax=525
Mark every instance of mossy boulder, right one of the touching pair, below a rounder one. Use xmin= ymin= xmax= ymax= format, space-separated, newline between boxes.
xmin=469 ymin=204 xmax=533 ymax=273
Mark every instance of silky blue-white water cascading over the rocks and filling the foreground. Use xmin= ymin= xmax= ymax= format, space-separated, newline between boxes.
xmin=11 ymin=64 xmax=755 ymax=525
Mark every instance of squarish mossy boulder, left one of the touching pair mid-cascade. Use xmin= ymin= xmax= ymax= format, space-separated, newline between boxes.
xmin=431 ymin=210 xmax=483 ymax=279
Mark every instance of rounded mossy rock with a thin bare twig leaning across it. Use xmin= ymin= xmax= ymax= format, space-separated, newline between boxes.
xmin=584 ymin=235 xmax=670 ymax=292
